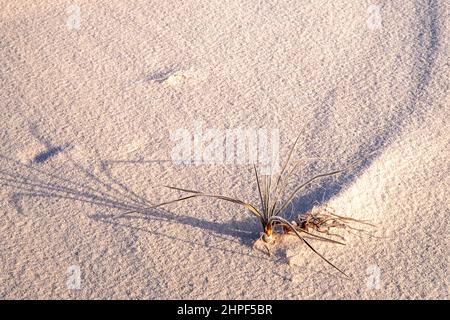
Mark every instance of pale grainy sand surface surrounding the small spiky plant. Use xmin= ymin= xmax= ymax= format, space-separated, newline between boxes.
xmin=0 ymin=0 xmax=450 ymax=299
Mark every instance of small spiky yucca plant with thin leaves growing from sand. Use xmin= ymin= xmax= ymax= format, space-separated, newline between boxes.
xmin=157 ymin=136 xmax=347 ymax=276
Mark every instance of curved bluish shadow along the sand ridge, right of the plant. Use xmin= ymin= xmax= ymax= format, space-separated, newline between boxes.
xmin=293 ymin=0 xmax=441 ymax=214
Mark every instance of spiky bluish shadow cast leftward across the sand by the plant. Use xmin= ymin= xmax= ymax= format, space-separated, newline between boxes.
xmin=0 ymin=155 xmax=264 ymax=250
